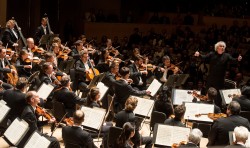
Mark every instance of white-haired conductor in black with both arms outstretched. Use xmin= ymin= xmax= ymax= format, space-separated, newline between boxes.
xmin=194 ymin=41 xmax=242 ymax=107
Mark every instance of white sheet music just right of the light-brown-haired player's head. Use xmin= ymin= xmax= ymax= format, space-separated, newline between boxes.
xmin=133 ymin=96 xmax=155 ymax=117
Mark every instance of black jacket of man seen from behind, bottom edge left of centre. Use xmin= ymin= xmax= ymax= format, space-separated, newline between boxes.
xmin=62 ymin=126 xmax=96 ymax=148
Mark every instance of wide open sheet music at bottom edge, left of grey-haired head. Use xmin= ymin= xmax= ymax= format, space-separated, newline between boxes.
xmin=154 ymin=124 xmax=190 ymax=146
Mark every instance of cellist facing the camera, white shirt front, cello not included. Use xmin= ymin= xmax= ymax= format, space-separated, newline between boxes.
xmin=74 ymin=50 xmax=91 ymax=92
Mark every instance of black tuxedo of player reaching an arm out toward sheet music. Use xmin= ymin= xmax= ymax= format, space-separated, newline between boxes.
xmin=114 ymin=79 xmax=146 ymax=112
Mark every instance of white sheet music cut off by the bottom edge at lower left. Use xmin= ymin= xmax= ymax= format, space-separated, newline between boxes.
xmin=24 ymin=132 xmax=50 ymax=148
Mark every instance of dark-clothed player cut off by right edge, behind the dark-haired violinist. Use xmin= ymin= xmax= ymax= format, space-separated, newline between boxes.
xmin=233 ymin=86 xmax=250 ymax=111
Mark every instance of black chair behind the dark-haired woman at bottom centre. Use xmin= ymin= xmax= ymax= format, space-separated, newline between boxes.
xmin=108 ymin=126 xmax=122 ymax=148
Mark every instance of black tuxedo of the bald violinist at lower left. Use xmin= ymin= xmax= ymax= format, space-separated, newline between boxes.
xmin=18 ymin=105 xmax=60 ymax=148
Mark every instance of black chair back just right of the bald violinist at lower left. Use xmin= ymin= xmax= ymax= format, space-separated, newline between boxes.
xmin=53 ymin=101 xmax=66 ymax=120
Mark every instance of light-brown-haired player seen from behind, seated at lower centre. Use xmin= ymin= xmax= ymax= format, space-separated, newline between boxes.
xmin=115 ymin=97 xmax=152 ymax=148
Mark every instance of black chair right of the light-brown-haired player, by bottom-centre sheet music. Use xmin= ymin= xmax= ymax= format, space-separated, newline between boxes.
xmin=150 ymin=111 xmax=167 ymax=136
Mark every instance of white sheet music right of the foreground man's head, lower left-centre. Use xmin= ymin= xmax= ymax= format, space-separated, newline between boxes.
xmin=81 ymin=106 xmax=106 ymax=130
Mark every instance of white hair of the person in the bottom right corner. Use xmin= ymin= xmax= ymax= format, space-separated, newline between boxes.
xmin=234 ymin=126 xmax=249 ymax=143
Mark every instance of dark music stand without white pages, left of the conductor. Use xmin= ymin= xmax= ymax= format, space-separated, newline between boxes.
xmin=164 ymin=74 xmax=189 ymax=88
